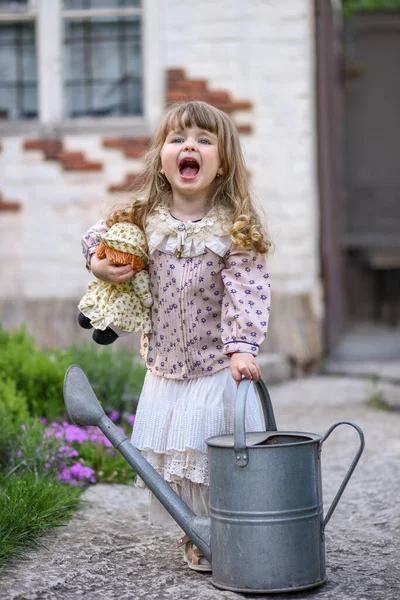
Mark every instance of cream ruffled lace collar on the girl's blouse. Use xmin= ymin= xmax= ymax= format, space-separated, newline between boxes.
xmin=146 ymin=204 xmax=232 ymax=257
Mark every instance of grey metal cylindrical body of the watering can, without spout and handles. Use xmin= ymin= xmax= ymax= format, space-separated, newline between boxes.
xmin=208 ymin=432 xmax=326 ymax=593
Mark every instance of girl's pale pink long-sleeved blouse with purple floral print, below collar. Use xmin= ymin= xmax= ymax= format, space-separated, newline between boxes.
xmin=83 ymin=206 xmax=270 ymax=379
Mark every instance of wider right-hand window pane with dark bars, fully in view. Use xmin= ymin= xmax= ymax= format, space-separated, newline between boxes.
xmin=64 ymin=17 xmax=142 ymax=118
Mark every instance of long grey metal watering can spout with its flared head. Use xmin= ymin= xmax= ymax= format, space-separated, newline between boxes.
xmin=64 ymin=365 xmax=211 ymax=561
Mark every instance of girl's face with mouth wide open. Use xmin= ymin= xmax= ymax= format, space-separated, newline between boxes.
xmin=161 ymin=125 xmax=222 ymax=201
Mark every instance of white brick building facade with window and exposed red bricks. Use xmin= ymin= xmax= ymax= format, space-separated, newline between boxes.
xmin=0 ymin=0 xmax=323 ymax=364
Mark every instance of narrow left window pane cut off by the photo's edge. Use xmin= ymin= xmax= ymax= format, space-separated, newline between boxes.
xmin=0 ymin=21 xmax=38 ymax=119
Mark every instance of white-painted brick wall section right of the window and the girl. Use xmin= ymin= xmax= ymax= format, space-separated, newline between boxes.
xmin=164 ymin=0 xmax=319 ymax=293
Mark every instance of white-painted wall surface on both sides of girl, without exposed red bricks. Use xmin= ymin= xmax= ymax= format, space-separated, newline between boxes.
xmin=0 ymin=0 xmax=320 ymax=330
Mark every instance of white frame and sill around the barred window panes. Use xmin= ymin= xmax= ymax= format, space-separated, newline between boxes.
xmin=0 ymin=0 xmax=164 ymax=135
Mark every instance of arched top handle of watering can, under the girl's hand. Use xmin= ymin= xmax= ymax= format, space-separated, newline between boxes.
xmin=233 ymin=379 xmax=276 ymax=467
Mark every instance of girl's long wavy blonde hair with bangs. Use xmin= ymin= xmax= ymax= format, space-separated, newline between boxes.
xmin=107 ymin=101 xmax=271 ymax=254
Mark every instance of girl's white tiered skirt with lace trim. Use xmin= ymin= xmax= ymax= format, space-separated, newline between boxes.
xmin=132 ymin=368 xmax=263 ymax=525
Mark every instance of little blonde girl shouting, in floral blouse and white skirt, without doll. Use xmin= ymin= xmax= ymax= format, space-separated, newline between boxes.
xmin=83 ymin=102 xmax=270 ymax=571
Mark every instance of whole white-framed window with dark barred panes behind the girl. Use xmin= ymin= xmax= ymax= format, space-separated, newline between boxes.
xmin=0 ymin=0 xmax=156 ymax=126
